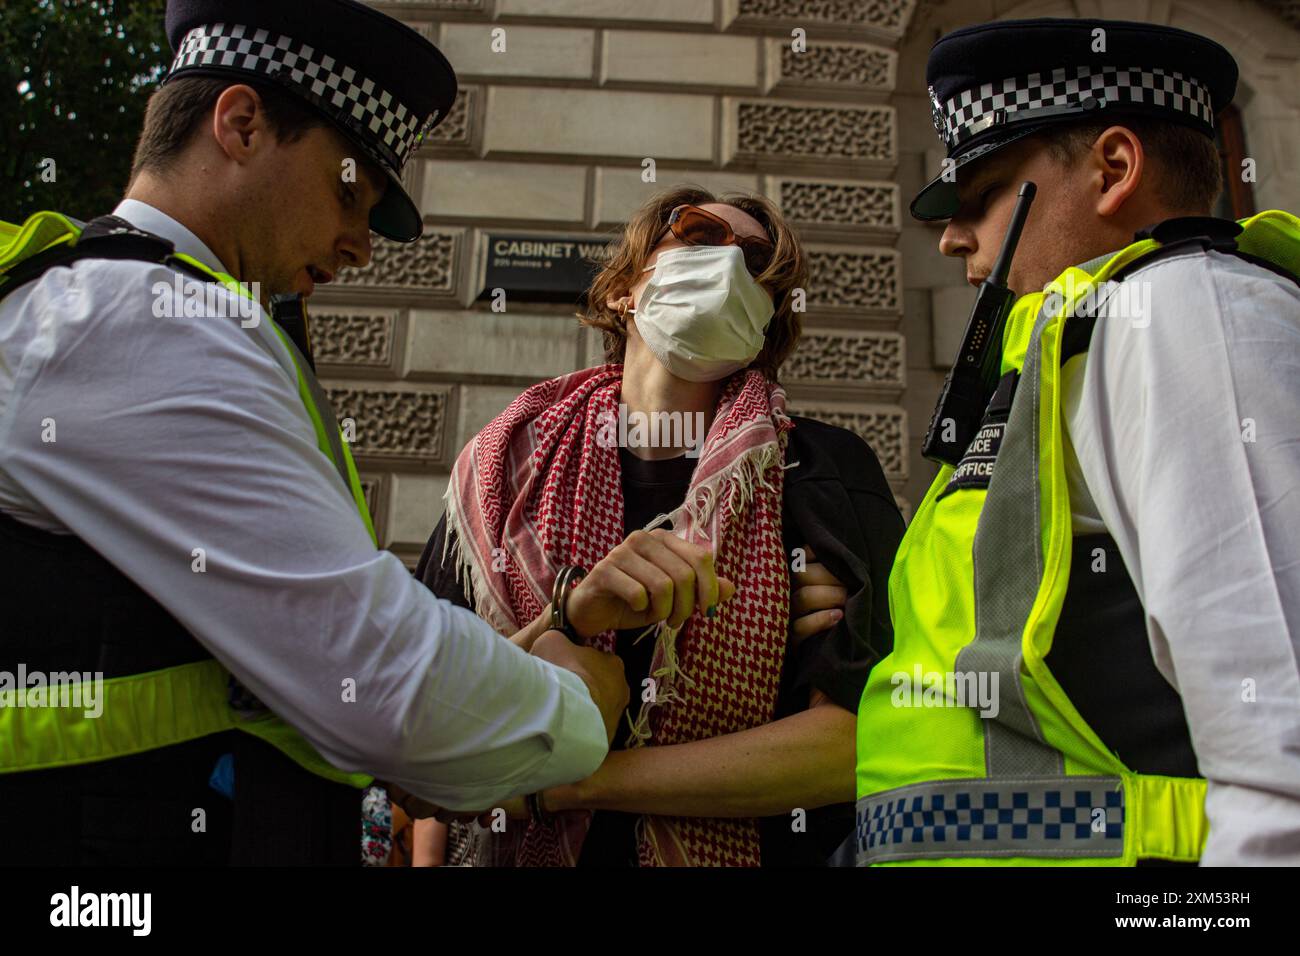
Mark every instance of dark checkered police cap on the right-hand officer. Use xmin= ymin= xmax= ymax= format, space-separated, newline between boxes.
xmin=911 ymin=20 xmax=1236 ymax=220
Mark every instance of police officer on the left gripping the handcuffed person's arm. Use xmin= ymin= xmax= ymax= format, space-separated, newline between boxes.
xmin=0 ymin=0 xmax=729 ymax=864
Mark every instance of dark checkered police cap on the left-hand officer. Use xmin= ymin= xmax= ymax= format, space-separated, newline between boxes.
xmin=168 ymin=0 xmax=456 ymax=242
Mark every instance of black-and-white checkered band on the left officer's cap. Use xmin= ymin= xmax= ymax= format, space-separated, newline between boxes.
xmin=172 ymin=23 xmax=438 ymax=174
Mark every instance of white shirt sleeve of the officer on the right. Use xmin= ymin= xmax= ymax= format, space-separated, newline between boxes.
xmin=1065 ymin=252 xmax=1300 ymax=865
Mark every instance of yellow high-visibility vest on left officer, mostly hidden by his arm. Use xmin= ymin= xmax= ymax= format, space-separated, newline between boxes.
xmin=0 ymin=212 xmax=376 ymax=787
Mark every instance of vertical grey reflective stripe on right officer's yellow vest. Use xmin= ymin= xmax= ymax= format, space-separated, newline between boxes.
xmin=954 ymin=299 xmax=1065 ymax=778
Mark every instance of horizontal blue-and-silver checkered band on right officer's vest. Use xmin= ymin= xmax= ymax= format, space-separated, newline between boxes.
xmin=857 ymin=777 xmax=1125 ymax=866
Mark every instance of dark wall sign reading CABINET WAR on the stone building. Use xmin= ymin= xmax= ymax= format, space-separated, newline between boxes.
xmin=478 ymin=233 xmax=607 ymax=303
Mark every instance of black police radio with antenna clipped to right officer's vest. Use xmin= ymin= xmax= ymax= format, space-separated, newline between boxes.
xmin=920 ymin=182 xmax=1037 ymax=467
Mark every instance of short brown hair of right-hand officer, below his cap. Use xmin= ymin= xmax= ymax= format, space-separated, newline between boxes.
xmin=1040 ymin=116 xmax=1223 ymax=215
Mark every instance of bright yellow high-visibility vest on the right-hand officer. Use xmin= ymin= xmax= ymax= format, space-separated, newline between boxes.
xmin=857 ymin=211 xmax=1300 ymax=865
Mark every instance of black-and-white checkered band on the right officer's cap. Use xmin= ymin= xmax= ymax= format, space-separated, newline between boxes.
xmin=930 ymin=66 xmax=1214 ymax=148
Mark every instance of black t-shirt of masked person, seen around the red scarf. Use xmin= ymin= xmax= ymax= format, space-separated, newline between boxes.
xmin=416 ymin=418 xmax=904 ymax=866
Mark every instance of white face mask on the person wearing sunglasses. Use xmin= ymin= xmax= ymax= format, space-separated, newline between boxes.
xmin=628 ymin=246 xmax=774 ymax=381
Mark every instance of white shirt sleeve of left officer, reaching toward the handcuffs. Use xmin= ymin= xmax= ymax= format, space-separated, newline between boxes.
xmin=0 ymin=260 xmax=607 ymax=810
